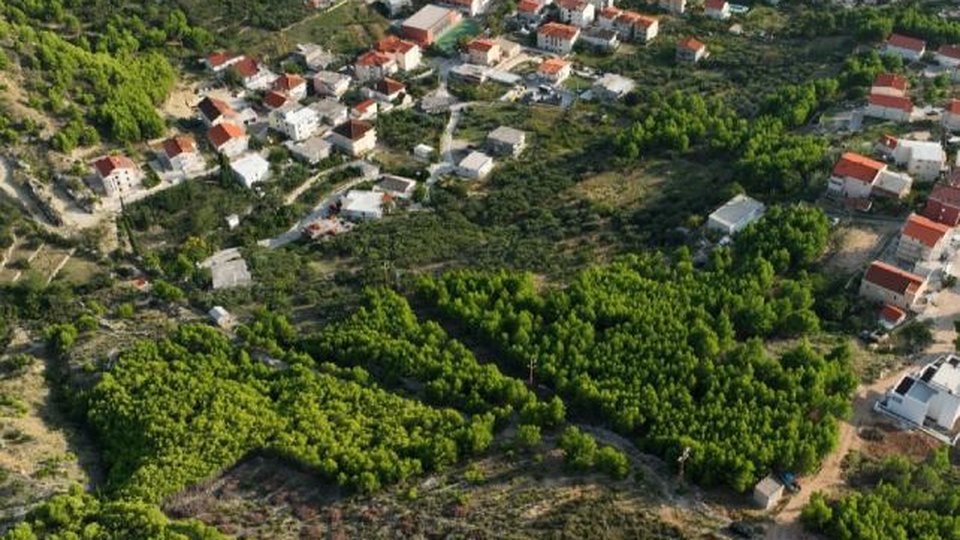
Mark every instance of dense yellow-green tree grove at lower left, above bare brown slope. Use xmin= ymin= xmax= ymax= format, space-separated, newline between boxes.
xmin=79 ymin=325 xmax=493 ymax=502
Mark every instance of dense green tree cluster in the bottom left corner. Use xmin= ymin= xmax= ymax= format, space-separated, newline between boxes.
xmin=2 ymin=486 xmax=227 ymax=540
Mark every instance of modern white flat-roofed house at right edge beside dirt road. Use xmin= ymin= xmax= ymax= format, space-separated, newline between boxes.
xmin=880 ymin=354 xmax=960 ymax=432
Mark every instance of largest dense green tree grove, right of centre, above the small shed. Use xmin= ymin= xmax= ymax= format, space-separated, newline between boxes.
xmin=423 ymin=227 xmax=856 ymax=490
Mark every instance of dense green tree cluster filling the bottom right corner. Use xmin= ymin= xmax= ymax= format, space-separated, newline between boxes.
xmin=802 ymin=448 xmax=960 ymax=540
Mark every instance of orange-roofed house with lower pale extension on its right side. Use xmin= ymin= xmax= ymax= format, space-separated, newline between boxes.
xmin=827 ymin=152 xmax=913 ymax=199
